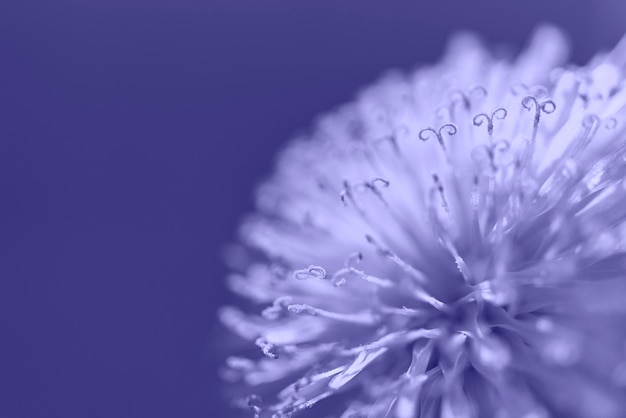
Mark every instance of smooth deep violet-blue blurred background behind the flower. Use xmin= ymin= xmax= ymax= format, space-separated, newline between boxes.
xmin=0 ymin=0 xmax=626 ymax=418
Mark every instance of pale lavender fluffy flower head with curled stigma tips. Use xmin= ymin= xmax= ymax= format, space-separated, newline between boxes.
xmin=220 ymin=27 xmax=626 ymax=418
